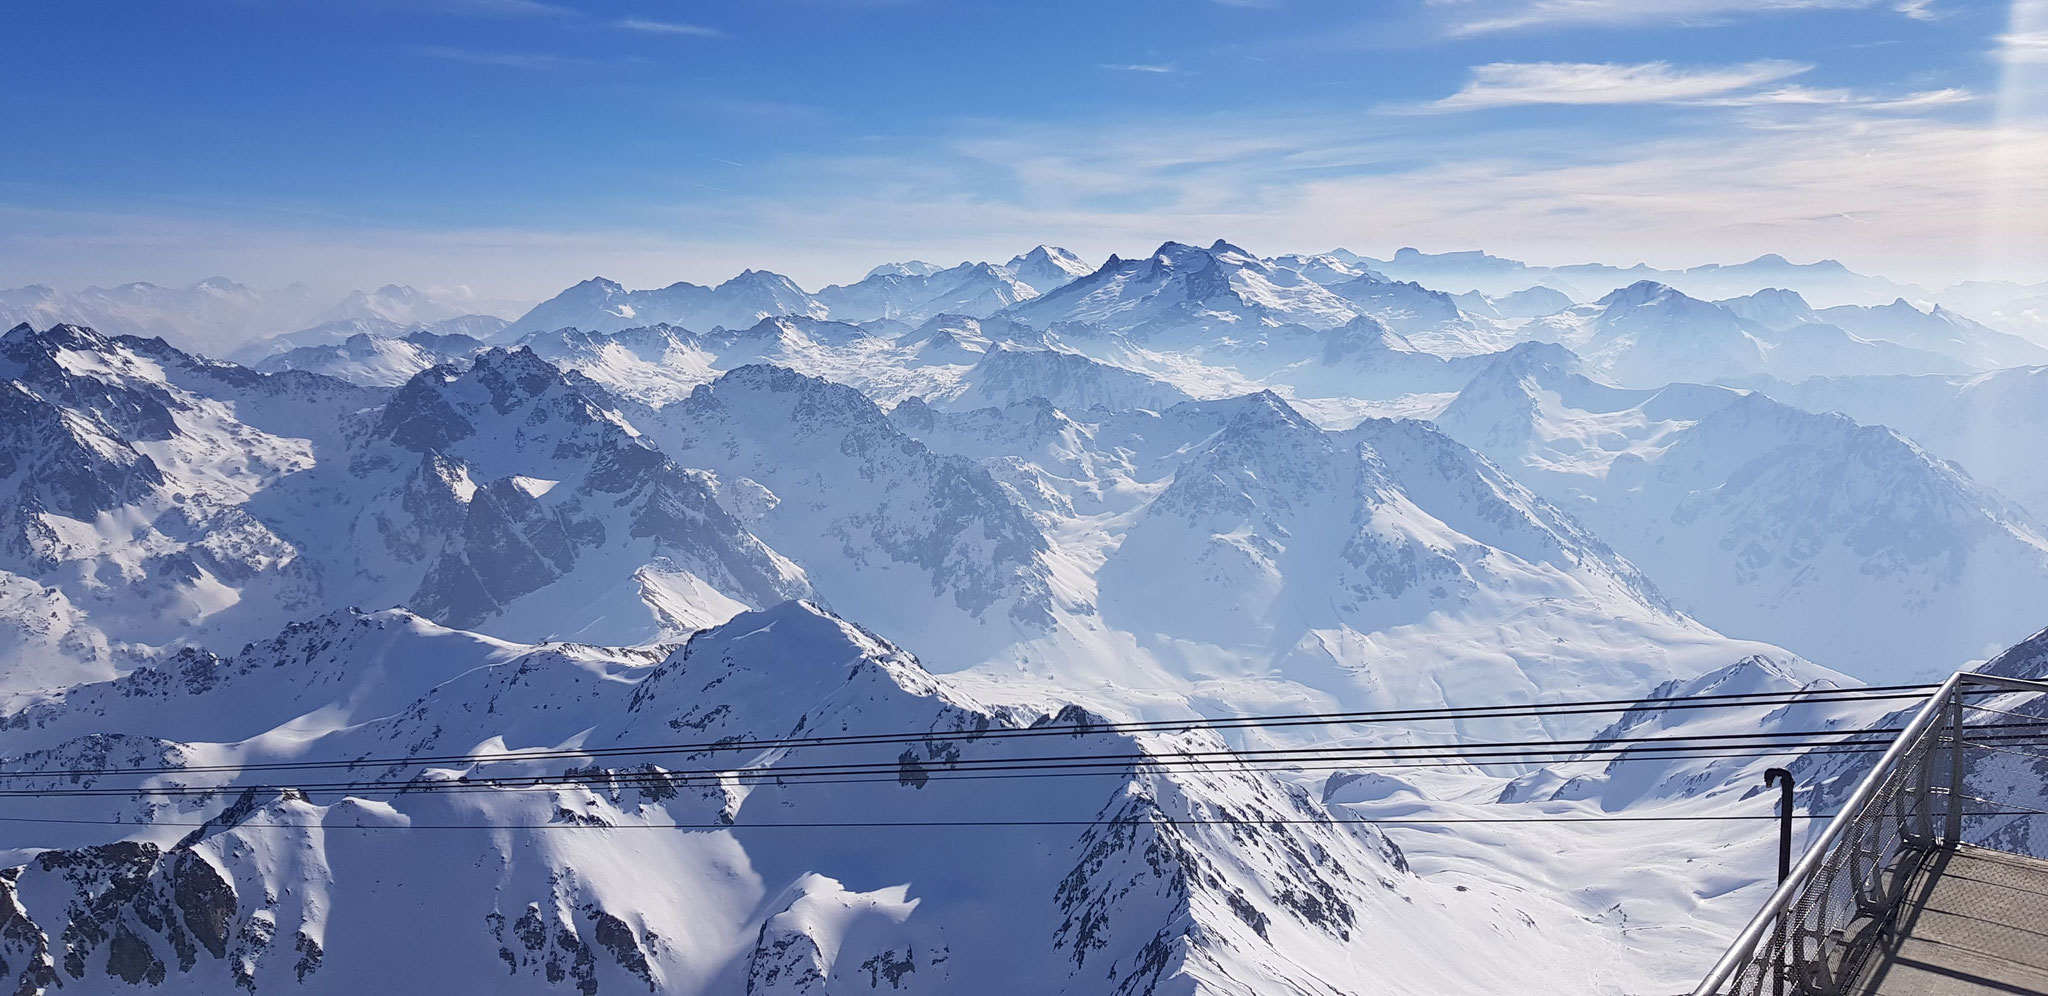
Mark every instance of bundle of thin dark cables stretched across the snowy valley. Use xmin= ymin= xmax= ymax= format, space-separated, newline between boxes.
xmin=12 ymin=684 xmax=2048 ymax=830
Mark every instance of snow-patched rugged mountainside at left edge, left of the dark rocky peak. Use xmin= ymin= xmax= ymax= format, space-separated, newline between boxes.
xmin=0 ymin=326 xmax=375 ymax=682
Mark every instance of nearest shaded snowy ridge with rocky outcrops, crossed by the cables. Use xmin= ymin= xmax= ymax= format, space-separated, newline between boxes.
xmin=0 ymin=603 xmax=1556 ymax=994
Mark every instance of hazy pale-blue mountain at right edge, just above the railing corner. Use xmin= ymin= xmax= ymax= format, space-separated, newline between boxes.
xmin=1438 ymin=346 xmax=2048 ymax=678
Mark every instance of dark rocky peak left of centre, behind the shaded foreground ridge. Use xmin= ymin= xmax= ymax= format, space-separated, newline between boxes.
xmin=319 ymin=348 xmax=809 ymax=635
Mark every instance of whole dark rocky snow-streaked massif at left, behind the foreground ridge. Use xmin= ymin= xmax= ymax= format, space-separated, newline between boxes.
xmin=0 ymin=326 xmax=811 ymax=664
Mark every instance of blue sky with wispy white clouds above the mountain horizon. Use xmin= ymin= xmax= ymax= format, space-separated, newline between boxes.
xmin=0 ymin=0 xmax=2048 ymax=297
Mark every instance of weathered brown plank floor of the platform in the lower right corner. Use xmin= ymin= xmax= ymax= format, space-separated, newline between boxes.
xmin=1849 ymin=846 xmax=2048 ymax=996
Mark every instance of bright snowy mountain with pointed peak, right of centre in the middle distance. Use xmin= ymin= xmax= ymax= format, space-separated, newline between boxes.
xmin=891 ymin=381 xmax=1794 ymax=729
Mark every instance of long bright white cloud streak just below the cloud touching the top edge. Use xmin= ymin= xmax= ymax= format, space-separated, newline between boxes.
xmin=1427 ymin=59 xmax=1812 ymax=111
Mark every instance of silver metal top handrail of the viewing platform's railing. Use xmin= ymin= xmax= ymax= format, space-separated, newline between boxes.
xmin=1692 ymin=670 xmax=2048 ymax=996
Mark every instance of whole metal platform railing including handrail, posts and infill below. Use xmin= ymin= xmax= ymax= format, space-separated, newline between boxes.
xmin=1692 ymin=672 xmax=2048 ymax=996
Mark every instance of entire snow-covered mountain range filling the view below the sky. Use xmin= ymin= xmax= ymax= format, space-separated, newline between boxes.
xmin=0 ymin=240 xmax=2048 ymax=996
